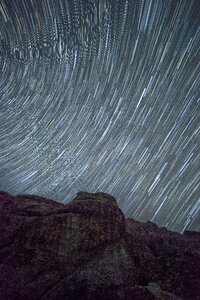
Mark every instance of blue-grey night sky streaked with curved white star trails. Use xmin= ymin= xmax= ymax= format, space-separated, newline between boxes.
xmin=0 ymin=0 xmax=200 ymax=232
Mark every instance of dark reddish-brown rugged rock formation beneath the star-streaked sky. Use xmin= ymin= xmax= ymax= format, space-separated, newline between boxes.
xmin=0 ymin=192 xmax=200 ymax=300
